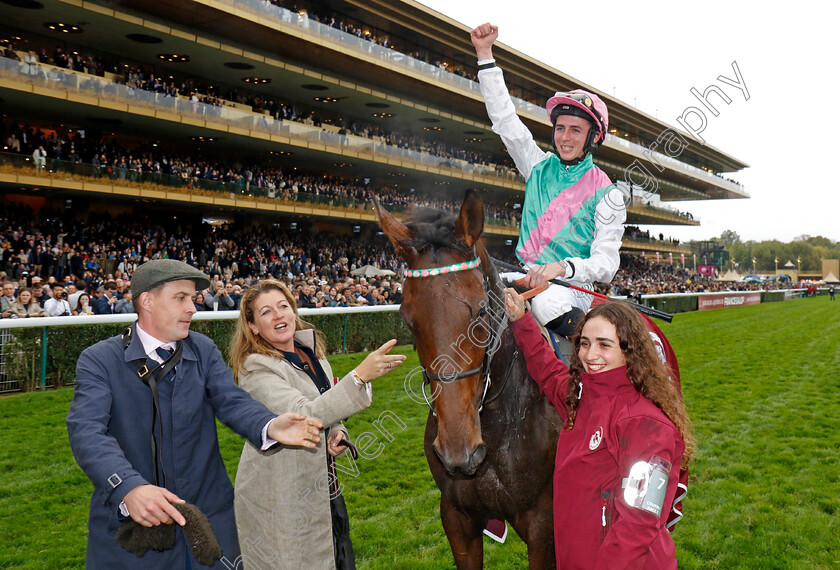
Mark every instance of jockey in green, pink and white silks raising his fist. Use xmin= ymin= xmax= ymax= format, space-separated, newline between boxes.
xmin=470 ymin=24 xmax=627 ymax=336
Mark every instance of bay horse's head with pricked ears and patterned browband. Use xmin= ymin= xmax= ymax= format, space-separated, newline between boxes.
xmin=377 ymin=193 xmax=495 ymax=475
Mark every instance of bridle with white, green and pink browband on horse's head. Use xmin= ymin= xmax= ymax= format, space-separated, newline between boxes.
xmin=405 ymin=253 xmax=519 ymax=417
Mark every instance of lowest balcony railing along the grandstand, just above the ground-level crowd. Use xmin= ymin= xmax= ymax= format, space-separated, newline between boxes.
xmin=0 ymin=152 xmax=519 ymax=228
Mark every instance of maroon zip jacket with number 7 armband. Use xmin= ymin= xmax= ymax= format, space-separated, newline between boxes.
xmin=512 ymin=312 xmax=685 ymax=570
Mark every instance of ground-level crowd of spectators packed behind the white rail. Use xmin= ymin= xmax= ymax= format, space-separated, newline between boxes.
xmin=0 ymin=199 xmax=808 ymax=318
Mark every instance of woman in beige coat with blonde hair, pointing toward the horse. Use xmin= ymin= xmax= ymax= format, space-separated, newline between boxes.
xmin=226 ymin=280 xmax=405 ymax=570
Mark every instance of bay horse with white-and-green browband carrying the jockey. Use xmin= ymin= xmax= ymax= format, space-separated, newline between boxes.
xmin=376 ymin=193 xmax=563 ymax=569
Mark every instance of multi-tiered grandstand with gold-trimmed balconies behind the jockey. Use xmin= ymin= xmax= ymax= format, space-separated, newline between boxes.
xmin=0 ymin=0 xmax=748 ymax=262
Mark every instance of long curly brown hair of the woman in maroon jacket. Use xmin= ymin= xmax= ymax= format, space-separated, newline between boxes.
xmin=564 ymin=301 xmax=695 ymax=468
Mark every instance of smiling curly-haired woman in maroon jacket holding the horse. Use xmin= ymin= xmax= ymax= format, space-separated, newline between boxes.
xmin=506 ymin=289 xmax=694 ymax=570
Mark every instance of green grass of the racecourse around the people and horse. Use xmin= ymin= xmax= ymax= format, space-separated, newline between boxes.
xmin=0 ymin=297 xmax=840 ymax=569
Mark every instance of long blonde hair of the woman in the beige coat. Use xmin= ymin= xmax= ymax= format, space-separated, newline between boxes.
xmin=229 ymin=279 xmax=326 ymax=382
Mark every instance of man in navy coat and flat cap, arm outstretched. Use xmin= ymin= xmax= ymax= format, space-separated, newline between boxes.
xmin=67 ymin=259 xmax=322 ymax=569
